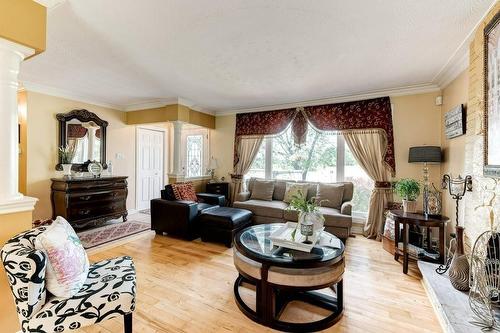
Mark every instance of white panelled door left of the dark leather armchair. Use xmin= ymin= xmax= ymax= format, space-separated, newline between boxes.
xmin=136 ymin=128 xmax=165 ymax=210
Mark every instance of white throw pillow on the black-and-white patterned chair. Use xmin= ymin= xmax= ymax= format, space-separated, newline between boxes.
xmin=35 ymin=216 xmax=89 ymax=298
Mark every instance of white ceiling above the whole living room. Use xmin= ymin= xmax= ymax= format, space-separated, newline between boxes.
xmin=20 ymin=0 xmax=495 ymax=113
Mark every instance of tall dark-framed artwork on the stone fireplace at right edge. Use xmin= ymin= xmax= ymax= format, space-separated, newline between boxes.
xmin=483 ymin=13 xmax=500 ymax=177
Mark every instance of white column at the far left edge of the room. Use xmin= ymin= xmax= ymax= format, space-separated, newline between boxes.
xmin=0 ymin=38 xmax=34 ymax=212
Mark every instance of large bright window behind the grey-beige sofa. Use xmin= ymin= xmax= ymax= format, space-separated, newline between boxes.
xmin=245 ymin=126 xmax=373 ymax=217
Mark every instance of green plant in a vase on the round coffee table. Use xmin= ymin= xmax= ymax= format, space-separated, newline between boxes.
xmin=287 ymin=191 xmax=325 ymax=242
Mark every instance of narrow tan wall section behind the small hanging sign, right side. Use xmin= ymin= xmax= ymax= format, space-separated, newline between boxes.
xmin=441 ymin=70 xmax=470 ymax=232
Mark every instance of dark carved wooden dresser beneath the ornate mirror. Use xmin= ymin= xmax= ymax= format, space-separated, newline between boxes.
xmin=50 ymin=177 xmax=128 ymax=228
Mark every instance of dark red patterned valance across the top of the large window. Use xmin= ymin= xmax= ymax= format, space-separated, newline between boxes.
xmin=234 ymin=97 xmax=396 ymax=174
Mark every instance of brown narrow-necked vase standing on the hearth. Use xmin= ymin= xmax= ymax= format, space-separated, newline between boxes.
xmin=448 ymin=226 xmax=469 ymax=291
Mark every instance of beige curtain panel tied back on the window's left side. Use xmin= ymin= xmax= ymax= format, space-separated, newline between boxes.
xmin=231 ymin=136 xmax=264 ymax=203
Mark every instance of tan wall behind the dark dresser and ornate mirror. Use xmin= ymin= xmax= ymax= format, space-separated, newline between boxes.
xmin=27 ymin=91 xmax=136 ymax=219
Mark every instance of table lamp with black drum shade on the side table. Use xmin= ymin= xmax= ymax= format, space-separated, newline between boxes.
xmin=408 ymin=146 xmax=441 ymax=216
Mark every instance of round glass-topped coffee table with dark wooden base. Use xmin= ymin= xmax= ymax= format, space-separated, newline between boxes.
xmin=234 ymin=223 xmax=344 ymax=332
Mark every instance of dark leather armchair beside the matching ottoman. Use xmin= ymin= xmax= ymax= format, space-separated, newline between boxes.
xmin=151 ymin=185 xmax=225 ymax=240
